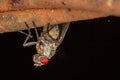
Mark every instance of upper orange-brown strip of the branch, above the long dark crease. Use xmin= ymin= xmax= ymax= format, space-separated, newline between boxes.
xmin=0 ymin=0 xmax=120 ymax=16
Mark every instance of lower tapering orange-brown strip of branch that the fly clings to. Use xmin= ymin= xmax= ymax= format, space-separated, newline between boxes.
xmin=0 ymin=9 xmax=106 ymax=33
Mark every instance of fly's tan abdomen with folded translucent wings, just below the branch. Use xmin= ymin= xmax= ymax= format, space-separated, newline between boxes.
xmin=44 ymin=23 xmax=70 ymax=46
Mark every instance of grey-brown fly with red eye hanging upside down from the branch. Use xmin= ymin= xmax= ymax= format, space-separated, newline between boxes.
xmin=19 ymin=21 xmax=70 ymax=67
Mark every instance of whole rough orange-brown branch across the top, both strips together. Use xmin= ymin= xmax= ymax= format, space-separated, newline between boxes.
xmin=0 ymin=0 xmax=120 ymax=33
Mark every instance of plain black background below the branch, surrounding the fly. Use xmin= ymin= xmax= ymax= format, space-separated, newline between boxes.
xmin=0 ymin=16 xmax=120 ymax=80
